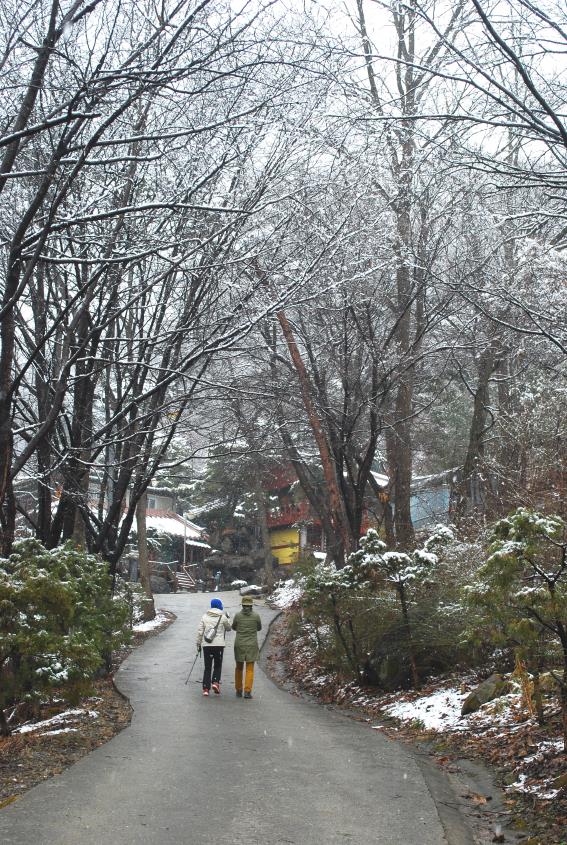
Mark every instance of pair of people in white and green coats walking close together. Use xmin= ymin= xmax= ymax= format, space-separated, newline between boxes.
xmin=197 ymin=596 xmax=262 ymax=698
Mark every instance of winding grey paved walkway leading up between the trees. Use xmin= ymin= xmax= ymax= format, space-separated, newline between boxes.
xmin=0 ymin=593 xmax=453 ymax=845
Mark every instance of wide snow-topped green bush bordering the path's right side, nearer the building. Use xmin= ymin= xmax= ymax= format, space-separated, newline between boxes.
xmin=293 ymin=525 xmax=474 ymax=688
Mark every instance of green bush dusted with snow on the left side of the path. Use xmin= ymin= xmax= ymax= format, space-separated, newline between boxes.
xmin=0 ymin=540 xmax=130 ymax=733
